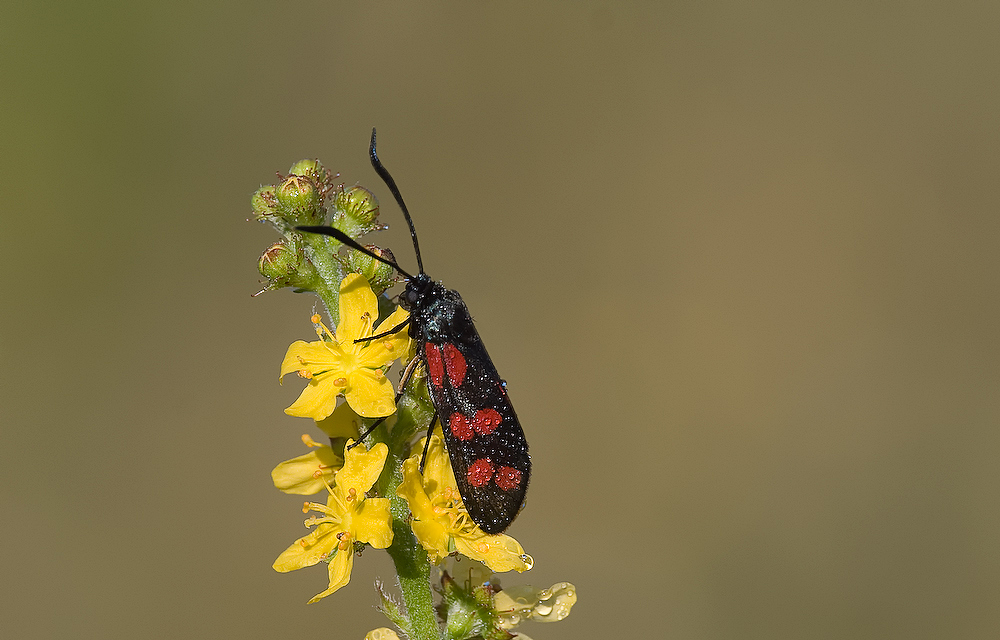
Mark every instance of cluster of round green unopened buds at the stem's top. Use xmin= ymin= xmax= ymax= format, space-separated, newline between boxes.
xmin=251 ymin=160 xmax=396 ymax=295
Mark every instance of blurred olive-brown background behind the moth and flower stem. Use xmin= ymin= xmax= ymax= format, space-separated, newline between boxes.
xmin=0 ymin=1 xmax=1000 ymax=640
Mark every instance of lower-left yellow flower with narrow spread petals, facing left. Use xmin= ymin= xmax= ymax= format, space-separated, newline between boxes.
xmin=273 ymin=442 xmax=392 ymax=604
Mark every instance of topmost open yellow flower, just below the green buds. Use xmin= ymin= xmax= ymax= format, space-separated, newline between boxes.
xmin=279 ymin=273 xmax=410 ymax=420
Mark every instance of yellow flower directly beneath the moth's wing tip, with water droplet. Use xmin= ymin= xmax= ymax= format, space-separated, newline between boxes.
xmin=396 ymin=427 xmax=533 ymax=572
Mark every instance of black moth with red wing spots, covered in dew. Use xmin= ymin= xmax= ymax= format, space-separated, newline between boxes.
xmin=297 ymin=129 xmax=531 ymax=533
